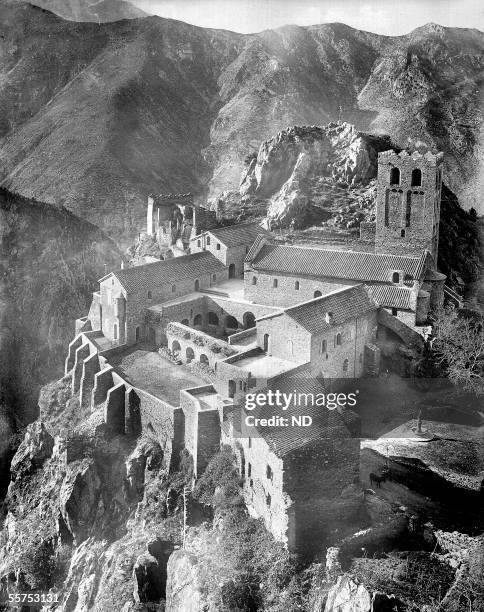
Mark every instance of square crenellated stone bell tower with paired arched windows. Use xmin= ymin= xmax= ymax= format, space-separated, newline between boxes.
xmin=375 ymin=151 xmax=443 ymax=262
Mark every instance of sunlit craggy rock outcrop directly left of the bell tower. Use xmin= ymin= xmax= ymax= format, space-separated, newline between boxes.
xmin=236 ymin=123 xmax=391 ymax=229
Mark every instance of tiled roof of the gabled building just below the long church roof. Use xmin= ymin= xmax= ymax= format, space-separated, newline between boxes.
xmin=284 ymin=285 xmax=378 ymax=334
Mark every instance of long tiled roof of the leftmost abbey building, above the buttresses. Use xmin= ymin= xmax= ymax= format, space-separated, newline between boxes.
xmin=104 ymin=251 xmax=225 ymax=293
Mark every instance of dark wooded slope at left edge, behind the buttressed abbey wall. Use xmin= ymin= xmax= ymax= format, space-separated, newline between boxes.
xmin=0 ymin=189 xmax=121 ymax=421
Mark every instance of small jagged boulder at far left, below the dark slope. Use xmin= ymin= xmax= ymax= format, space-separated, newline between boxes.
xmin=10 ymin=421 xmax=54 ymax=481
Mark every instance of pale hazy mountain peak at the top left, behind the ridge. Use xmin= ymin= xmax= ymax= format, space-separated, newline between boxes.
xmin=19 ymin=0 xmax=147 ymax=23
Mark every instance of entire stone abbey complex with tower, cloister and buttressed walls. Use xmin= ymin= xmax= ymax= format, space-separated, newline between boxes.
xmin=65 ymin=150 xmax=458 ymax=552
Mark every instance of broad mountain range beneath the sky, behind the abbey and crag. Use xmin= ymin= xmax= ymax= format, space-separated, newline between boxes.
xmin=0 ymin=0 xmax=484 ymax=243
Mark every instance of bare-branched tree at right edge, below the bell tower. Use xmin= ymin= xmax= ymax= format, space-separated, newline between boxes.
xmin=431 ymin=308 xmax=484 ymax=395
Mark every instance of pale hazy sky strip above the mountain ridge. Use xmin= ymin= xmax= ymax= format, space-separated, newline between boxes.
xmin=131 ymin=0 xmax=484 ymax=35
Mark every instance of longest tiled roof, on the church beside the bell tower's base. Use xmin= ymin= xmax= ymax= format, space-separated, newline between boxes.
xmin=252 ymin=244 xmax=427 ymax=282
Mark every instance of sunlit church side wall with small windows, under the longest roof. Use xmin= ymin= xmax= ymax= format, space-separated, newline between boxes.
xmin=244 ymin=268 xmax=356 ymax=307
